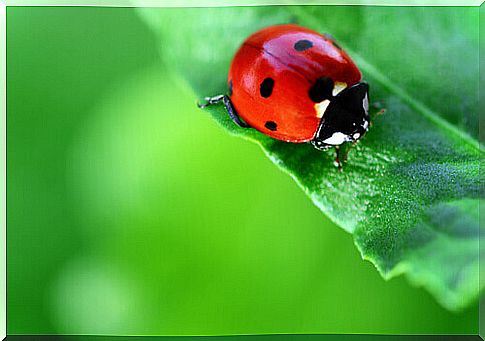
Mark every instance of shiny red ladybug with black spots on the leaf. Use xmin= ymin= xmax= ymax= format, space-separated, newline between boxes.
xmin=199 ymin=24 xmax=370 ymax=168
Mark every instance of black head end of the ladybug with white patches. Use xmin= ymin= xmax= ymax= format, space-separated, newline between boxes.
xmin=312 ymin=82 xmax=369 ymax=149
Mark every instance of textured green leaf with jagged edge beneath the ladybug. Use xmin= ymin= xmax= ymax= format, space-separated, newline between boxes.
xmin=141 ymin=6 xmax=484 ymax=310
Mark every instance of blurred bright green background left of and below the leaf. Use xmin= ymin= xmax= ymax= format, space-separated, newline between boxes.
xmin=7 ymin=7 xmax=478 ymax=335
